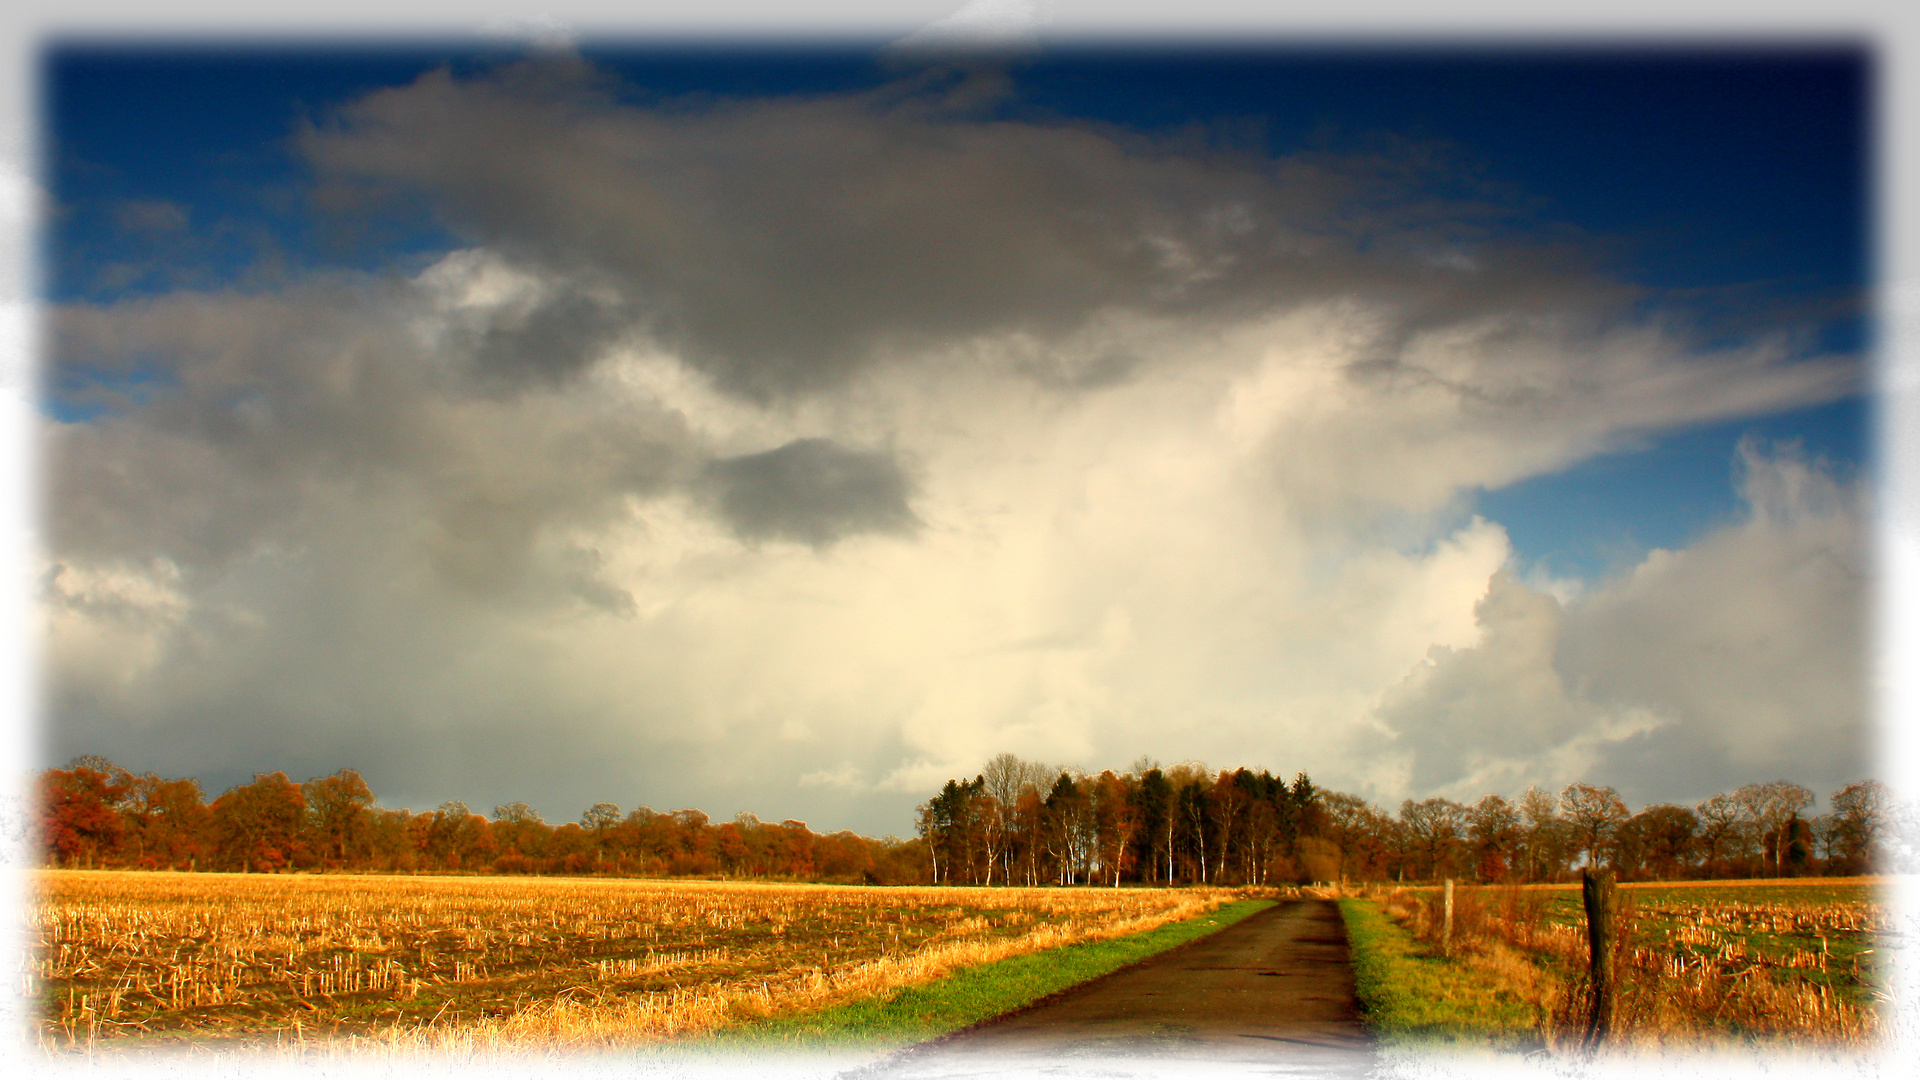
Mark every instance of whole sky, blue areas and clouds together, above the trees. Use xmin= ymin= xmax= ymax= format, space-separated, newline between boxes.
xmin=35 ymin=38 xmax=1876 ymax=834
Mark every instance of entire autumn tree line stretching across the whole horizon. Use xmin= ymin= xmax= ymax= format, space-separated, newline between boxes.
xmin=38 ymin=753 xmax=1895 ymax=886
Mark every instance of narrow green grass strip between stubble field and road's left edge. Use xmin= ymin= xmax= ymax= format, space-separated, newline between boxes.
xmin=705 ymin=899 xmax=1273 ymax=1049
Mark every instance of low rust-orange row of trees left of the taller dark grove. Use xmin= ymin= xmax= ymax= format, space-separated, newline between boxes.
xmin=38 ymin=757 xmax=925 ymax=884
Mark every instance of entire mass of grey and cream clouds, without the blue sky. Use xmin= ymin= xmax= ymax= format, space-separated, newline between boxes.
xmin=40 ymin=58 xmax=1864 ymax=832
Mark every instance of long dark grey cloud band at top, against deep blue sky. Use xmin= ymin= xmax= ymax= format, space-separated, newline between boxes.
xmin=301 ymin=61 xmax=1613 ymax=400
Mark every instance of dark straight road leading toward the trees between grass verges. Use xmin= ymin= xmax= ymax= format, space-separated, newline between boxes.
xmin=858 ymin=899 xmax=1373 ymax=1080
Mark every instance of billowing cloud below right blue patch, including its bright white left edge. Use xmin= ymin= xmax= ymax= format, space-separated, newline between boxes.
xmin=1379 ymin=440 xmax=1872 ymax=801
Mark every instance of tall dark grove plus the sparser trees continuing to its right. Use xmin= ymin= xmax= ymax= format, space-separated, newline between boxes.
xmin=918 ymin=753 xmax=1891 ymax=886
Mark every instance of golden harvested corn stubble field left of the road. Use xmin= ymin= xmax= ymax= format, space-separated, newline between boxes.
xmin=25 ymin=871 xmax=1223 ymax=1049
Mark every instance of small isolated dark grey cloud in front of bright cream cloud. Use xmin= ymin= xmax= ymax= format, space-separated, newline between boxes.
xmin=707 ymin=438 xmax=920 ymax=548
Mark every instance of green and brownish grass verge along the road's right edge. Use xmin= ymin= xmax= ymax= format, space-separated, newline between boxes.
xmin=1340 ymin=897 xmax=1540 ymax=1049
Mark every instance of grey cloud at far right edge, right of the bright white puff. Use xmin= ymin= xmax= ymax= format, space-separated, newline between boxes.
xmin=1563 ymin=440 xmax=1874 ymax=792
